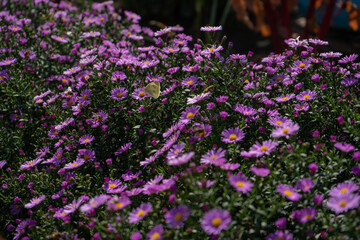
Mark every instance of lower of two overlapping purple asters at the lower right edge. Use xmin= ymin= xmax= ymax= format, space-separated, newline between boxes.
xmin=326 ymin=194 xmax=360 ymax=214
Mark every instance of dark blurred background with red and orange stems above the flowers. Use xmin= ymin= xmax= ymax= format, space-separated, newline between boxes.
xmin=110 ymin=0 xmax=360 ymax=59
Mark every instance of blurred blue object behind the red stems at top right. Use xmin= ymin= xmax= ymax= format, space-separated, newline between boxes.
xmin=298 ymin=0 xmax=360 ymax=32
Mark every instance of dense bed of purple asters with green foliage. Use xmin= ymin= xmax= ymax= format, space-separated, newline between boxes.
xmin=0 ymin=0 xmax=360 ymax=240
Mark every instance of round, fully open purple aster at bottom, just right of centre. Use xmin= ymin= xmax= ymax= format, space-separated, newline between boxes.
xmin=201 ymin=208 xmax=231 ymax=235
